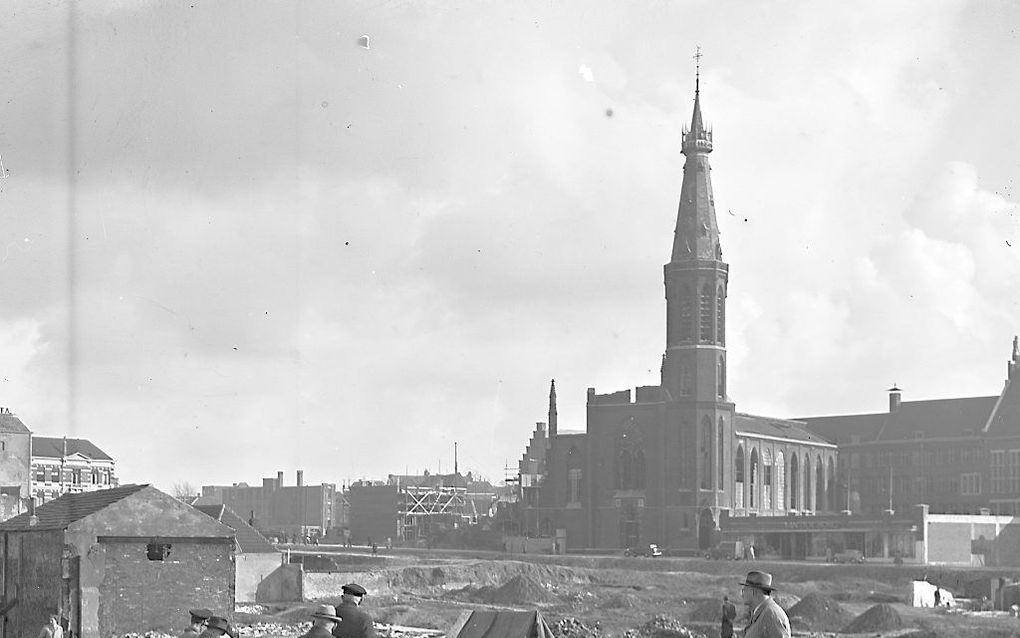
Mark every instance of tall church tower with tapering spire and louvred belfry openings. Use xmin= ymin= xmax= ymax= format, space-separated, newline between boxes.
xmin=662 ymin=65 xmax=733 ymax=536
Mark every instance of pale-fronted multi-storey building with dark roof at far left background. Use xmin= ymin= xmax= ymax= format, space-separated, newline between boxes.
xmin=32 ymin=436 xmax=118 ymax=503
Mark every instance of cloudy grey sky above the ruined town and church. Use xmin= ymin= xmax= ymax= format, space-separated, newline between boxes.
xmin=0 ymin=0 xmax=1020 ymax=489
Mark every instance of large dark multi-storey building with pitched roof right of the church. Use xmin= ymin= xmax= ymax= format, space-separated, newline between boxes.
xmin=799 ymin=339 xmax=1020 ymax=516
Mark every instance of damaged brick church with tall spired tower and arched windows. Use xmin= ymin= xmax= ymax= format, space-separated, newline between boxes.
xmin=521 ymin=81 xmax=840 ymax=549
